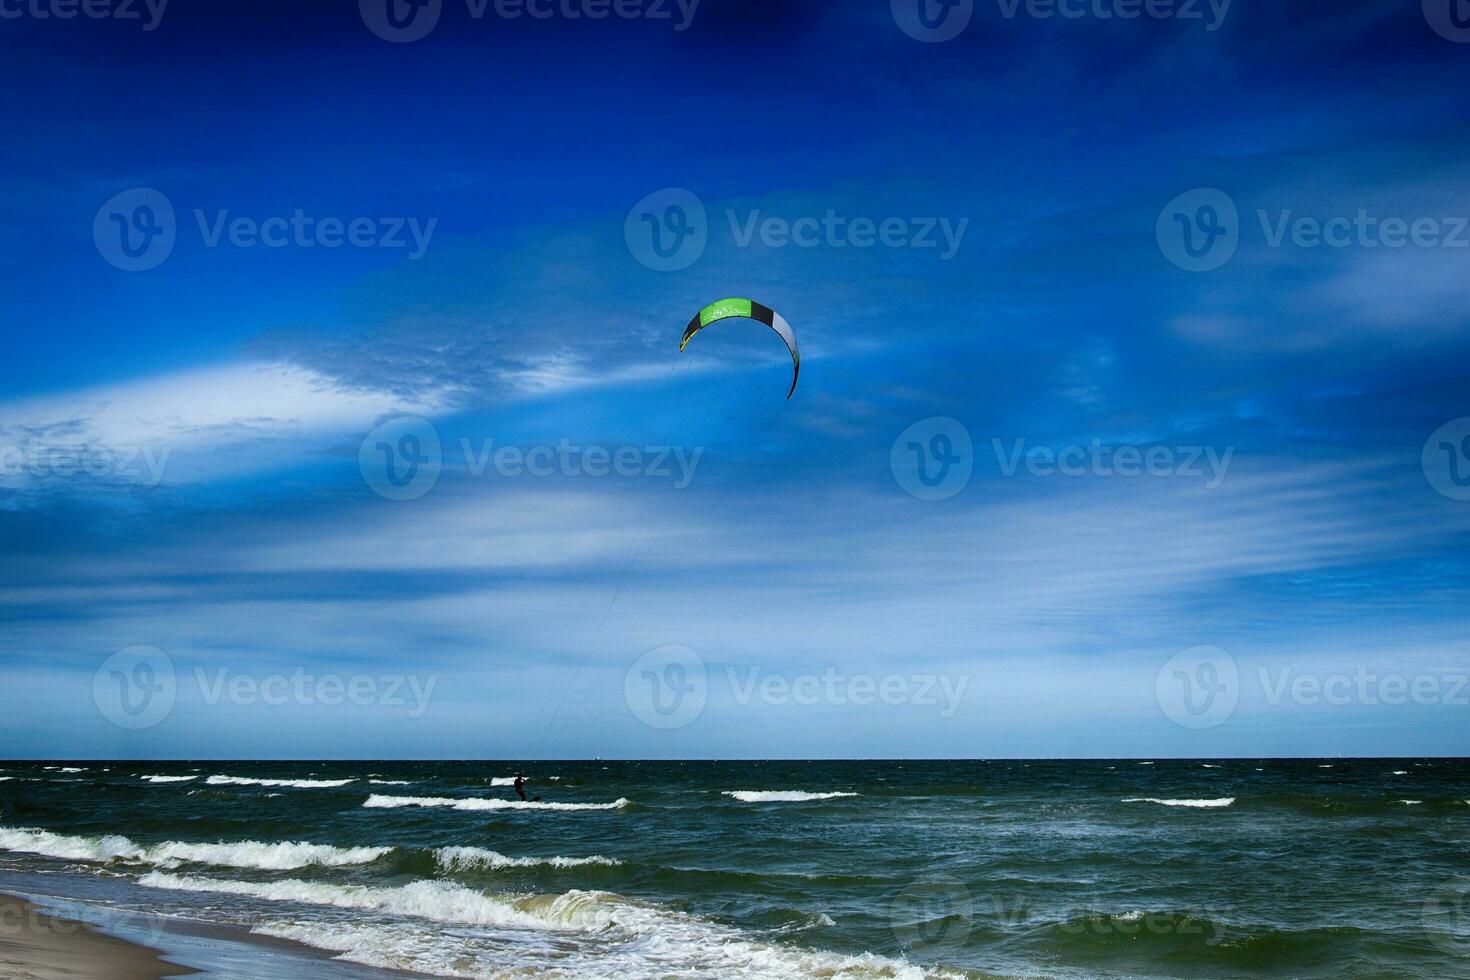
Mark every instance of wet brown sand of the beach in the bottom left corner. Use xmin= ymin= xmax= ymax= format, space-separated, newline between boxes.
xmin=0 ymin=895 xmax=194 ymax=980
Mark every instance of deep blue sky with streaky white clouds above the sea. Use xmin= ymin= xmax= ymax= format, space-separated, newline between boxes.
xmin=0 ymin=0 xmax=1470 ymax=758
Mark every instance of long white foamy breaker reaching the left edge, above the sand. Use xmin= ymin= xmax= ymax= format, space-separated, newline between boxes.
xmin=0 ymin=827 xmax=392 ymax=871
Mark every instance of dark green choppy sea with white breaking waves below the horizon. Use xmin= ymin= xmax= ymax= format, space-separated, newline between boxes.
xmin=0 ymin=758 xmax=1470 ymax=980
